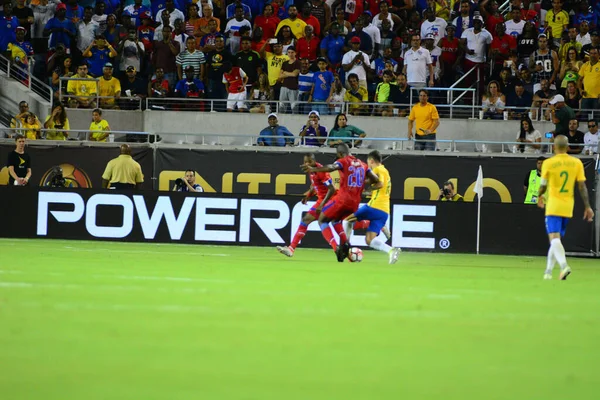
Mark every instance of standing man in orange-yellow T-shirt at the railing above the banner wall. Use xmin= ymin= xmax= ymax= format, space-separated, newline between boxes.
xmin=408 ymin=89 xmax=440 ymax=151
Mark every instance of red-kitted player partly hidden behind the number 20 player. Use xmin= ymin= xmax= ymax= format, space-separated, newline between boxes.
xmin=277 ymin=153 xmax=337 ymax=257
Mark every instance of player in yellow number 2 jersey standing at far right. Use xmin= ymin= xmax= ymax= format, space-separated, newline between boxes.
xmin=538 ymin=135 xmax=594 ymax=280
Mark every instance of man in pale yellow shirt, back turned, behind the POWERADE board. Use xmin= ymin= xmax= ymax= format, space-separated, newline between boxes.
xmin=102 ymin=144 xmax=144 ymax=190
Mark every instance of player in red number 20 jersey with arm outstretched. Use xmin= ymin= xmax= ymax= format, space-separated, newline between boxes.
xmin=302 ymin=143 xmax=381 ymax=262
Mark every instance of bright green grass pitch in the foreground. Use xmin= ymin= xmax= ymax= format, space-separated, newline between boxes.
xmin=0 ymin=240 xmax=600 ymax=400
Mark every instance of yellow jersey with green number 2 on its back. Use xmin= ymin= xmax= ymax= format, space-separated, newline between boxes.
xmin=542 ymin=154 xmax=585 ymax=218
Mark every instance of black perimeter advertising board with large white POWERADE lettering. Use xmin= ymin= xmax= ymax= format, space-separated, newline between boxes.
xmin=0 ymin=186 xmax=595 ymax=257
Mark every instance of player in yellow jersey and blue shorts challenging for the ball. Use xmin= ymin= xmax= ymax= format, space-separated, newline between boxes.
xmin=344 ymin=150 xmax=400 ymax=264
